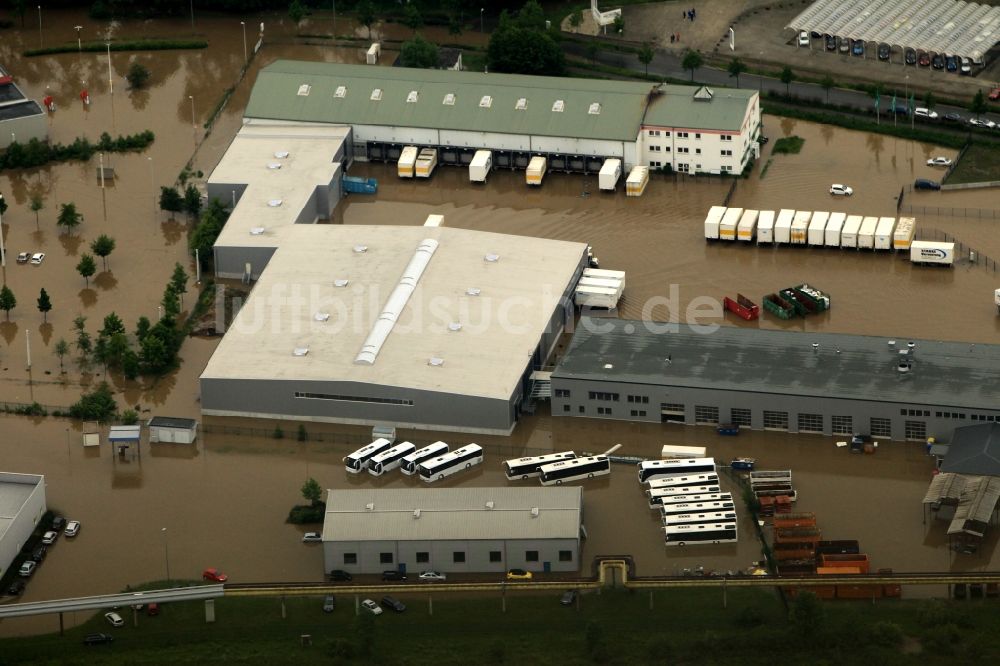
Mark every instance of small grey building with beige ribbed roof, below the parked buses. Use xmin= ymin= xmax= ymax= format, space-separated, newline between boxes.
xmin=323 ymin=487 xmax=583 ymax=574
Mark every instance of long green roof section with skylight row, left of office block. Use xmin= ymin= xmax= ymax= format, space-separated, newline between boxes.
xmin=244 ymin=60 xmax=656 ymax=141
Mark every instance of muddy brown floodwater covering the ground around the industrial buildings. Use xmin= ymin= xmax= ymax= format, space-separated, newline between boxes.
xmin=0 ymin=13 xmax=1000 ymax=635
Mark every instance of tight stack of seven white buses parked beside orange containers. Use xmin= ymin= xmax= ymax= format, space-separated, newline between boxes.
xmin=637 ymin=458 xmax=737 ymax=546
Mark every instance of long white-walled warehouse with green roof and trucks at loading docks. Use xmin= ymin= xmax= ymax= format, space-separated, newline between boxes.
xmin=244 ymin=60 xmax=760 ymax=174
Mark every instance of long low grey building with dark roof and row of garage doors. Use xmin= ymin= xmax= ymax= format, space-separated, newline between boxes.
xmin=552 ymin=318 xmax=1000 ymax=441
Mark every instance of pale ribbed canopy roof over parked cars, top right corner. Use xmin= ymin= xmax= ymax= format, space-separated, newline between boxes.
xmin=785 ymin=0 xmax=1000 ymax=60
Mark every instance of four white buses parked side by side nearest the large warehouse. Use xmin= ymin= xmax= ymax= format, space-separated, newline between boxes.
xmin=344 ymin=438 xmax=483 ymax=483
